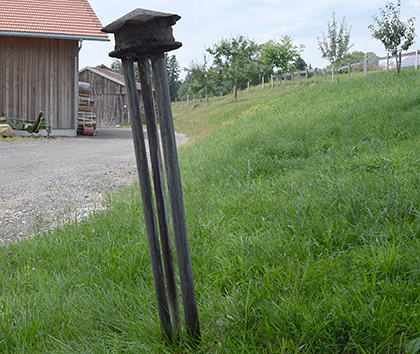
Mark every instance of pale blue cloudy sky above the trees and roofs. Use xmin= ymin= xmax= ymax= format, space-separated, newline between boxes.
xmin=79 ymin=0 xmax=420 ymax=74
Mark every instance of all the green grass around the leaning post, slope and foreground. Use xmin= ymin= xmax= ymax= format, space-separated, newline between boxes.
xmin=0 ymin=71 xmax=420 ymax=354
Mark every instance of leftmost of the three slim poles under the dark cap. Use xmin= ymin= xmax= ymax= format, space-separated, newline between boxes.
xmin=122 ymin=58 xmax=172 ymax=341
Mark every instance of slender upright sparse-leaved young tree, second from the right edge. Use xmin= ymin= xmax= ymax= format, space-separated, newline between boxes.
xmin=318 ymin=12 xmax=353 ymax=80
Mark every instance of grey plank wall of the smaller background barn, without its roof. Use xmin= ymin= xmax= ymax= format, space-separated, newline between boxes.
xmin=79 ymin=70 xmax=128 ymax=127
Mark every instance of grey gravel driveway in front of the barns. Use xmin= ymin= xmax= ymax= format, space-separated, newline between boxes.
xmin=0 ymin=129 xmax=186 ymax=245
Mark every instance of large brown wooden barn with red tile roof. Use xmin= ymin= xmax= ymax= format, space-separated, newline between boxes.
xmin=0 ymin=0 xmax=108 ymax=136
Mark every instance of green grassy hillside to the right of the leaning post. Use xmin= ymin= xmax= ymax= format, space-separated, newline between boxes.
xmin=175 ymin=72 xmax=420 ymax=353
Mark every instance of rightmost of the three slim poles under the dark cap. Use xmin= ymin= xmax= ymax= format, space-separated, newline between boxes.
xmin=151 ymin=53 xmax=200 ymax=342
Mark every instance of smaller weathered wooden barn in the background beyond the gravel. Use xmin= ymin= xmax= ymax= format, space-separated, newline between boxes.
xmin=79 ymin=65 xmax=142 ymax=128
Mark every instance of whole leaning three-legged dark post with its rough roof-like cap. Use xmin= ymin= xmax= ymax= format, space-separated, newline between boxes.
xmin=103 ymin=9 xmax=200 ymax=342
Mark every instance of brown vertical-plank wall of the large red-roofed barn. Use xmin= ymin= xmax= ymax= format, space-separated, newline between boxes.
xmin=0 ymin=37 xmax=78 ymax=129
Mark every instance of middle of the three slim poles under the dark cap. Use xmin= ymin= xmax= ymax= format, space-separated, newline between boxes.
xmin=138 ymin=57 xmax=182 ymax=334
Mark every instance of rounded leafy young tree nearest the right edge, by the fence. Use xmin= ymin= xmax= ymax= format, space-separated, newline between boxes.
xmin=368 ymin=0 xmax=416 ymax=76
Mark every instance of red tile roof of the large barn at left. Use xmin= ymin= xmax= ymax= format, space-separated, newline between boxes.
xmin=0 ymin=0 xmax=108 ymax=40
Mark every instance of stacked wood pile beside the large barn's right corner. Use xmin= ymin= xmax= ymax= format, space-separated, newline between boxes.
xmin=77 ymin=81 xmax=96 ymax=135
